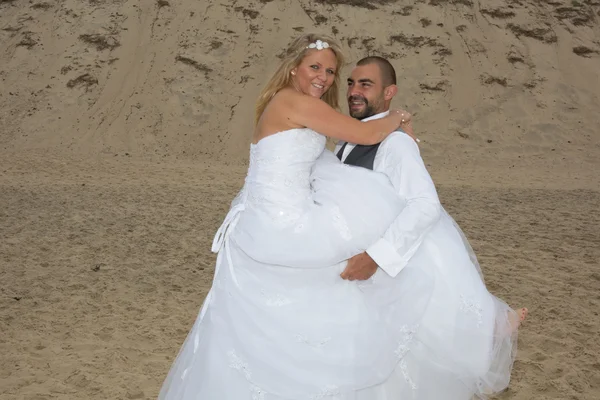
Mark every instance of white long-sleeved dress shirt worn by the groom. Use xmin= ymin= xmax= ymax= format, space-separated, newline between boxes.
xmin=335 ymin=111 xmax=442 ymax=277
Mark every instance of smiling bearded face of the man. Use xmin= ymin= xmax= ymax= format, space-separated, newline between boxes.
xmin=346 ymin=64 xmax=385 ymax=119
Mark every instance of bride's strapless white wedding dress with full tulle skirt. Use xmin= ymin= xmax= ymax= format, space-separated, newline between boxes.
xmin=159 ymin=129 xmax=516 ymax=400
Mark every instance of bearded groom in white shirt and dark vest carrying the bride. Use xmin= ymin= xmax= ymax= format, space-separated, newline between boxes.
xmin=335 ymin=57 xmax=441 ymax=281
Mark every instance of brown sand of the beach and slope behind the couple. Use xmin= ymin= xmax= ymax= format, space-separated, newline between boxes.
xmin=0 ymin=0 xmax=600 ymax=400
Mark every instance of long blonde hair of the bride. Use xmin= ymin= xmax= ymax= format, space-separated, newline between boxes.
xmin=254 ymin=33 xmax=344 ymax=125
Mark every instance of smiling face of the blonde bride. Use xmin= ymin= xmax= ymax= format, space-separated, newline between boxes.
xmin=292 ymin=49 xmax=337 ymax=98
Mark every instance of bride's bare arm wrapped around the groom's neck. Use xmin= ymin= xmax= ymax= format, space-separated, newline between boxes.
xmin=282 ymin=91 xmax=404 ymax=145
